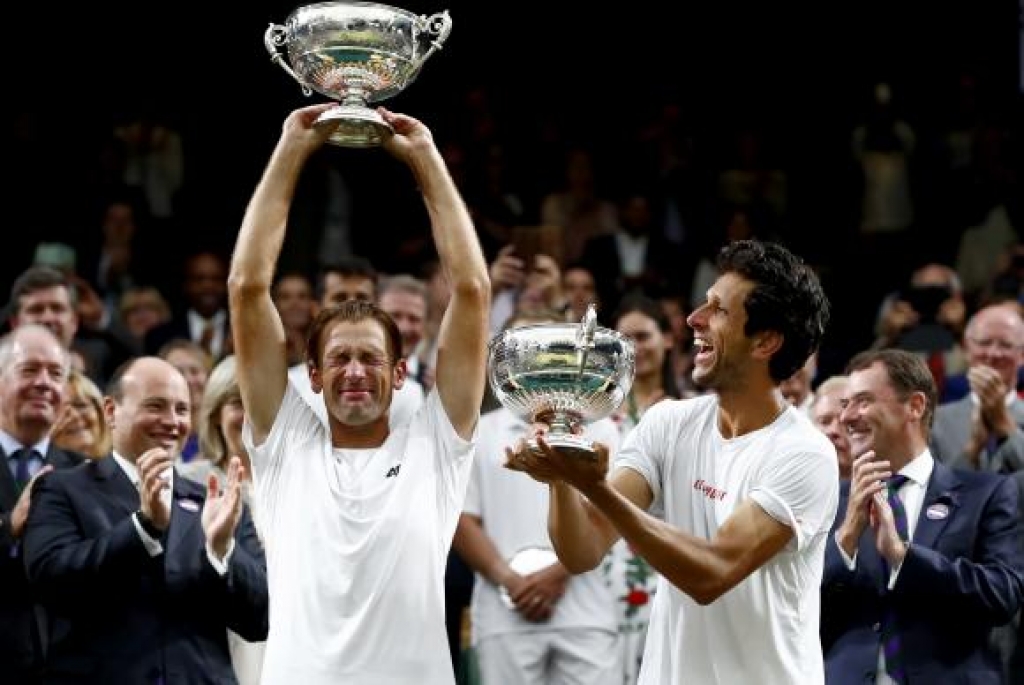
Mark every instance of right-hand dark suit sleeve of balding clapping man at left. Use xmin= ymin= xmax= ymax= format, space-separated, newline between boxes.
xmin=197 ymin=501 xmax=269 ymax=642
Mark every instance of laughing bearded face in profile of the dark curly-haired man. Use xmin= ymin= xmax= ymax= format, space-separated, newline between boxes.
xmin=686 ymin=273 xmax=754 ymax=392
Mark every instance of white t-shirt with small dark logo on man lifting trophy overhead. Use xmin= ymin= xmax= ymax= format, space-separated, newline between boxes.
xmin=243 ymin=383 xmax=473 ymax=685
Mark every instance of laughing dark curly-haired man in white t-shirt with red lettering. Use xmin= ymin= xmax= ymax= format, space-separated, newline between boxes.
xmin=507 ymin=241 xmax=839 ymax=685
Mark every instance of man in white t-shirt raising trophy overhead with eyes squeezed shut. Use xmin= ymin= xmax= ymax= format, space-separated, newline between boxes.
xmin=228 ymin=97 xmax=490 ymax=685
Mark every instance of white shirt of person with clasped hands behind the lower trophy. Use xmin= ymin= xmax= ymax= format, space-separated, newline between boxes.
xmin=463 ymin=406 xmax=620 ymax=645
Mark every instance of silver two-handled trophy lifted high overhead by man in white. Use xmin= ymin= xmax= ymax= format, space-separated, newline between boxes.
xmin=263 ymin=2 xmax=452 ymax=147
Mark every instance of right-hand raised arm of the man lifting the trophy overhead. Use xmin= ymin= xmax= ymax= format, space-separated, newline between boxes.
xmin=380 ymin=109 xmax=490 ymax=438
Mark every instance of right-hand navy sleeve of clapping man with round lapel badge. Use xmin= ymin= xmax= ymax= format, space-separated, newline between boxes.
xmin=892 ymin=478 xmax=1024 ymax=625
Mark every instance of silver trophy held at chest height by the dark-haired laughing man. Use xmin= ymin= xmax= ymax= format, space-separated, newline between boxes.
xmin=487 ymin=305 xmax=636 ymax=460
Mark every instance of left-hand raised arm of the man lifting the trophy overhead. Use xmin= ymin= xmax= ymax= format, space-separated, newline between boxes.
xmin=227 ymin=104 xmax=336 ymax=444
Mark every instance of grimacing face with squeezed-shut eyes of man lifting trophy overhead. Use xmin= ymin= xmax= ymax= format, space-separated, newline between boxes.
xmin=310 ymin=318 xmax=404 ymax=426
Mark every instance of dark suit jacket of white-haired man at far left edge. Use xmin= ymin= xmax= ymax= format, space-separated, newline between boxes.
xmin=0 ymin=442 xmax=85 ymax=685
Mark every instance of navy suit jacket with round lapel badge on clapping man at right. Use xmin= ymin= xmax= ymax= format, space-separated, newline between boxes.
xmin=821 ymin=462 xmax=1024 ymax=685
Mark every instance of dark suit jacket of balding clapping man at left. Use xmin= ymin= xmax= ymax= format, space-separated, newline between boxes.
xmin=25 ymin=457 xmax=267 ymax=685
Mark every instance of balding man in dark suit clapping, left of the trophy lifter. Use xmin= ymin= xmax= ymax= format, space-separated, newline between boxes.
xmin=25 ymin=357 xmax=267 ymax=685
